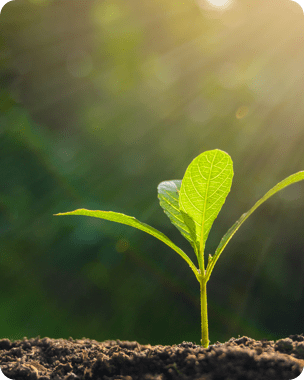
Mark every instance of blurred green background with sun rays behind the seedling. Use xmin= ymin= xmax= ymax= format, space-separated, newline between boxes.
xmin=0 ymin=0 xmax=304 ymax=345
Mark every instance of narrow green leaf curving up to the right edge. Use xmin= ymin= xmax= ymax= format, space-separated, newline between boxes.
xmin=207 ymin=171 xmax=304 ymax=281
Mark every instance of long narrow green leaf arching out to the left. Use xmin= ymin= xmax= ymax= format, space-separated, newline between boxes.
xmin=54 ymin=208 xmax=199 ymax=281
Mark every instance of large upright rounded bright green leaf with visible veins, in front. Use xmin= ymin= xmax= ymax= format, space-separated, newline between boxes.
xmin=179 ymin=149 xmax=233 ymax=262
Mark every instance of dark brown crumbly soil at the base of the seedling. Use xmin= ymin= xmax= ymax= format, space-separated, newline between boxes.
xmin=0 ymin=334 xmax=304 ymax=380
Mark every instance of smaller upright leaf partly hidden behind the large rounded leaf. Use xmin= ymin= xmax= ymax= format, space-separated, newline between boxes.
xmin=157 ymin=179 xmax=199 ymax=254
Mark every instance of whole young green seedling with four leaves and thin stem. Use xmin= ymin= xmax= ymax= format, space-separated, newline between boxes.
xmin=54 ymin=149 xmax=304 ymax=348
